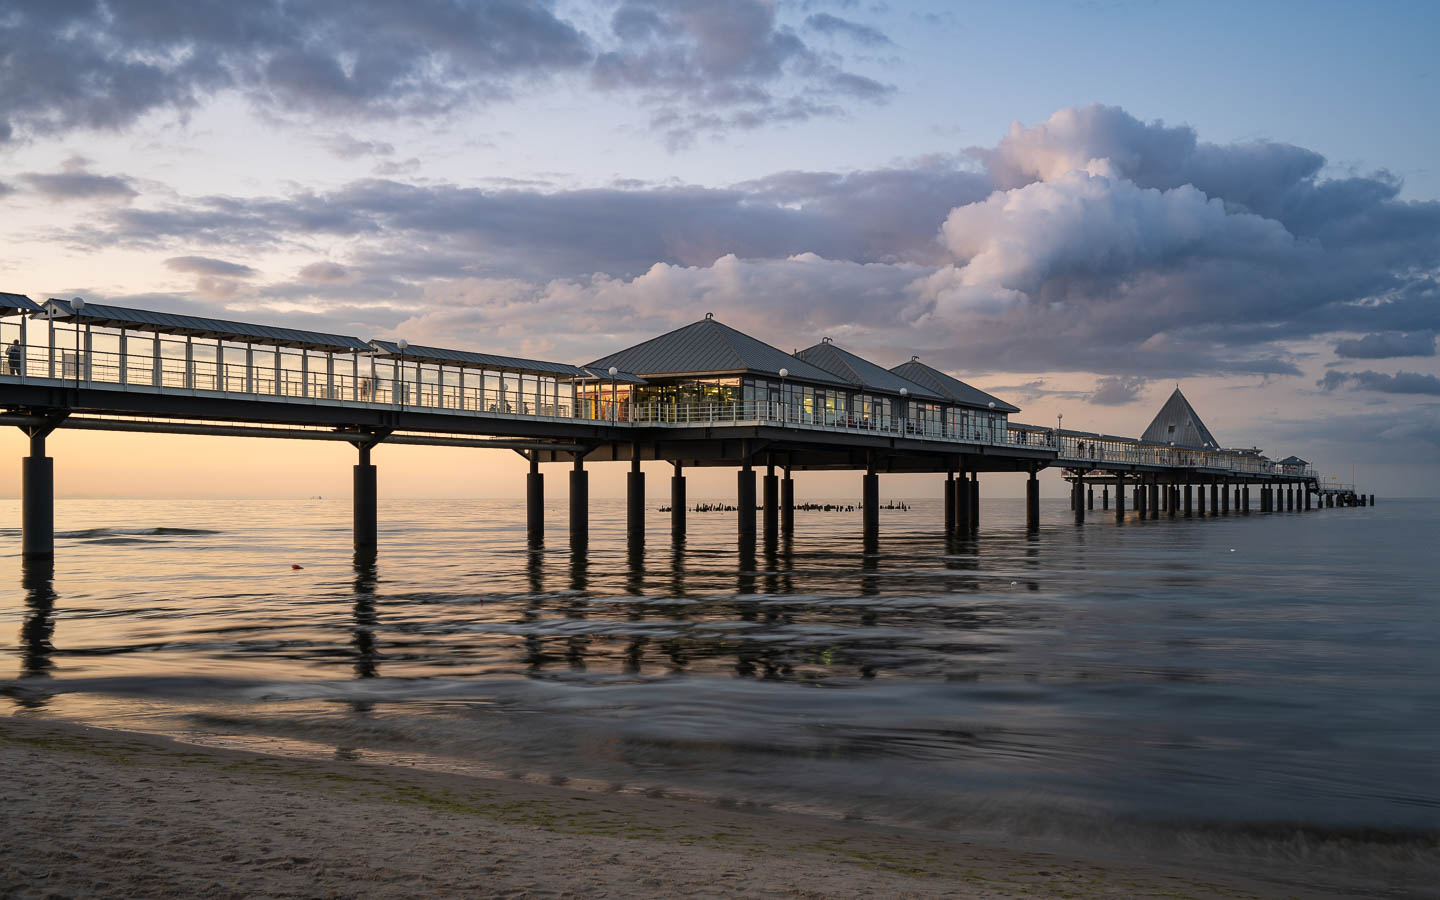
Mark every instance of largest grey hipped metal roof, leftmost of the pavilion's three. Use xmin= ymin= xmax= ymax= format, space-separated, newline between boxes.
xmin=589 ymin=314 xmax=844 ymax=387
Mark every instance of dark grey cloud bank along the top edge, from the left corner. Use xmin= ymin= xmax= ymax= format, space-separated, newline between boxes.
xmin=0 ymin=0 xmax=893 ymax=147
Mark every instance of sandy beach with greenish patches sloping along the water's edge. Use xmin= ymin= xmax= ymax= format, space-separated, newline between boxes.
xmin=0 ymin=717 xmax=1319 ymax=897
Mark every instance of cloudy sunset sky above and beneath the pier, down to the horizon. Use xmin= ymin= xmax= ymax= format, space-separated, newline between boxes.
xmin=0 ymin=0 xmax=1440 ymax=498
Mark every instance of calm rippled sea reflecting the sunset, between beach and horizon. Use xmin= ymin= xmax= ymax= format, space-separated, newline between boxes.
xmin=0 ymin=500 xmax=1440 ymax=877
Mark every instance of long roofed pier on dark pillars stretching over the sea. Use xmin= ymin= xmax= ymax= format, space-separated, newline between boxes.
xmin=0 ymin=294 xmax=1374 ymax=557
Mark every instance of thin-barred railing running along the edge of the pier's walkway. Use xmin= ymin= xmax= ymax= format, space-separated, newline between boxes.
xmin=0 ymin=338 xmax=1307 ymax=478
